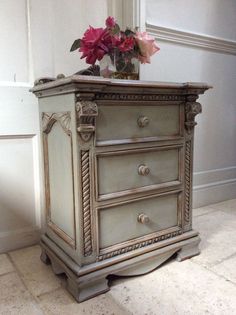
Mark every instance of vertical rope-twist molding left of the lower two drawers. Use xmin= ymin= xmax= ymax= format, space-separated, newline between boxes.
xmin=81 ymin=150 xmax=92 ymax=256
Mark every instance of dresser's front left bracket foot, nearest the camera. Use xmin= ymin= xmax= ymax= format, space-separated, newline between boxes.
xmin=67 ymin=276 xmax=110 ymax=302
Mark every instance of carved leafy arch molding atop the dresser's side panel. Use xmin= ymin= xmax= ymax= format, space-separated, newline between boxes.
xmin=42 ymin=112 xmax=71 ymax=135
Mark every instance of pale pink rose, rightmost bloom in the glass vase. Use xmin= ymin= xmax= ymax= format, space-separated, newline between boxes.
xmin=135 ymin=32 xmax=160 ymax=63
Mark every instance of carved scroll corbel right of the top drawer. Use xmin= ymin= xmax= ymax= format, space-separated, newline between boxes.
xmin=185 ymin=95 xmax=202 ymax=134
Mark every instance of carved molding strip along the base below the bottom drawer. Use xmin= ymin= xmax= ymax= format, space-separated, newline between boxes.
xmin=97 ymin=230 xmax=183 ymax=261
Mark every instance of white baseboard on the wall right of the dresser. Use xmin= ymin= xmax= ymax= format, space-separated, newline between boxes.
xmin=193 ymin=166 xmax=236 ymax=208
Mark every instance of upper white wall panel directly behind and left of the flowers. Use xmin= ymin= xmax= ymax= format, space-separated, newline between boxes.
xmin=30 ymin=0 xmax=108 ymax=78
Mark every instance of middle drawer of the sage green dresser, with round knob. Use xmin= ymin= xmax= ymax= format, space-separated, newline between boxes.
xmin=96 ymin=145 xmax=183 ymax=200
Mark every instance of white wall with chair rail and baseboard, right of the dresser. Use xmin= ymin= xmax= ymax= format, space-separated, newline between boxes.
xmin=142 ymin=0 xmax=236 ymax=207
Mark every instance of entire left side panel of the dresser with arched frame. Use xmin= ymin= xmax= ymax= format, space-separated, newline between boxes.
xmin=39 ymin=94 xmax=81 ymax=261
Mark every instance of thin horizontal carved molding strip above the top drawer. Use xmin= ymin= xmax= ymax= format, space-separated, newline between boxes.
xmin=95 ymin=93 xmax=185 ymax=102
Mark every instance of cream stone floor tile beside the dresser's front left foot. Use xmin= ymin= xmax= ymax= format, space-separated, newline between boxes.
xmin=9 ymin=246 xmax=61 ymax=296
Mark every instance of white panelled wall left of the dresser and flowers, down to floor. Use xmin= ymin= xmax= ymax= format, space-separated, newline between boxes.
xmin=0 ymin=0 xmax=108 ymax=252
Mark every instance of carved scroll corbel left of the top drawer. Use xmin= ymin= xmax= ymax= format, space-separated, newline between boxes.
xmin=76 ymin=101 xmax=98 ymax=142
